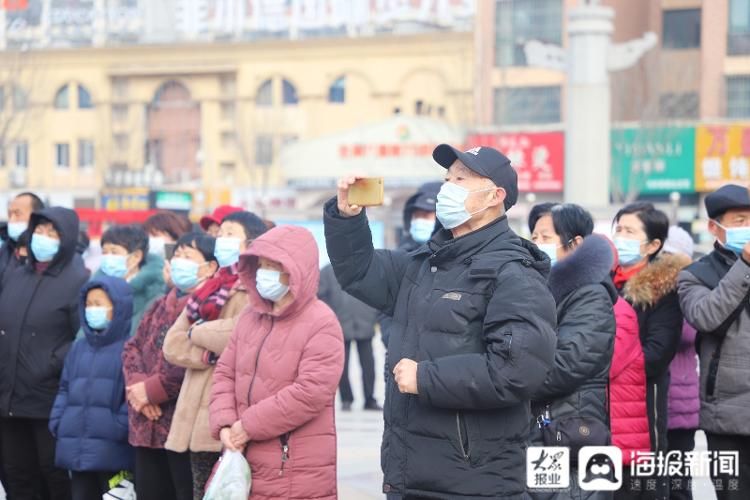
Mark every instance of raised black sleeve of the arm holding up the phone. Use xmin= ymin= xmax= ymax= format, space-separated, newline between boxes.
xmin=323 ymin=198 xmax=409 ymax=314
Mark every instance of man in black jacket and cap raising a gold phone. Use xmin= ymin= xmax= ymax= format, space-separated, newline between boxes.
xmin=324 ymin=146 xmax=556 ymax=500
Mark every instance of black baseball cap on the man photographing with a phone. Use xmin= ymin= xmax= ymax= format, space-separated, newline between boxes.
xmin=432 ymin=144 xmax=518 ymax=210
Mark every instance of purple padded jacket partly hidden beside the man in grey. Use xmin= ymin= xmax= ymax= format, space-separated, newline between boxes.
xmin=669 ymin=322 xmax=700 ymax=429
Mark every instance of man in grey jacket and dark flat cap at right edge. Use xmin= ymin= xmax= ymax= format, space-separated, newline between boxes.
xmin=678 ymin=184 xmax=750 ymax=500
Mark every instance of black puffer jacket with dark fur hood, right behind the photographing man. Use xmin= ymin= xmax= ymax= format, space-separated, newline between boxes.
xmin=530 ymin=236 xmax=618 ymax=499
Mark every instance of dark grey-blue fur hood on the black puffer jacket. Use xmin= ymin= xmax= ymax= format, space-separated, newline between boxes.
xmin=548 ymin=235 xmax=614 ymax=304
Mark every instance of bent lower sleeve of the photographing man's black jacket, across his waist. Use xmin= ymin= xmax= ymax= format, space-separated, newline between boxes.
xmin=417 ymin=262 xmax=556 ymax=410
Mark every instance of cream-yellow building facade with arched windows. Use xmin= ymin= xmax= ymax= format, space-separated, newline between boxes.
xmin=0 ymin=32 xmax=474 ymax=206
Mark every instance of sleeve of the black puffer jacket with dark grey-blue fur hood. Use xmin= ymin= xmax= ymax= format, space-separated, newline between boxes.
xmin=534 ymin=284 xmax=615 ymax=401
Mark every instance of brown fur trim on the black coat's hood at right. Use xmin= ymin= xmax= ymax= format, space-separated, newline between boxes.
xmin=623 ymin=254 xmax=692 ymax=307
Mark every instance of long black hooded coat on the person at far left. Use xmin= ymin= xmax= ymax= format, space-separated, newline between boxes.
xmin=0 ymin=207 xmax=89 ymax=419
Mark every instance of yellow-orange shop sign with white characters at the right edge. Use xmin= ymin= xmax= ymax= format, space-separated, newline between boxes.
xmin=695 ymin=124 xmax=750 ymax=191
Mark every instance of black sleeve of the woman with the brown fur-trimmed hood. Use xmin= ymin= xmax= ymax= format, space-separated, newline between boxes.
xmin=639 ymin=292 xmax=682 ymax=378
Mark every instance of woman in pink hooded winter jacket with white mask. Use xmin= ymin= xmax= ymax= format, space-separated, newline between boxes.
xmin=209 ymin=226 xmax=344 ymax=500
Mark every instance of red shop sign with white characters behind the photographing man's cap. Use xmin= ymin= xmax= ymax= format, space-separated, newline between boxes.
xmin=466 ymin=132 xmax=565 ymax=193
